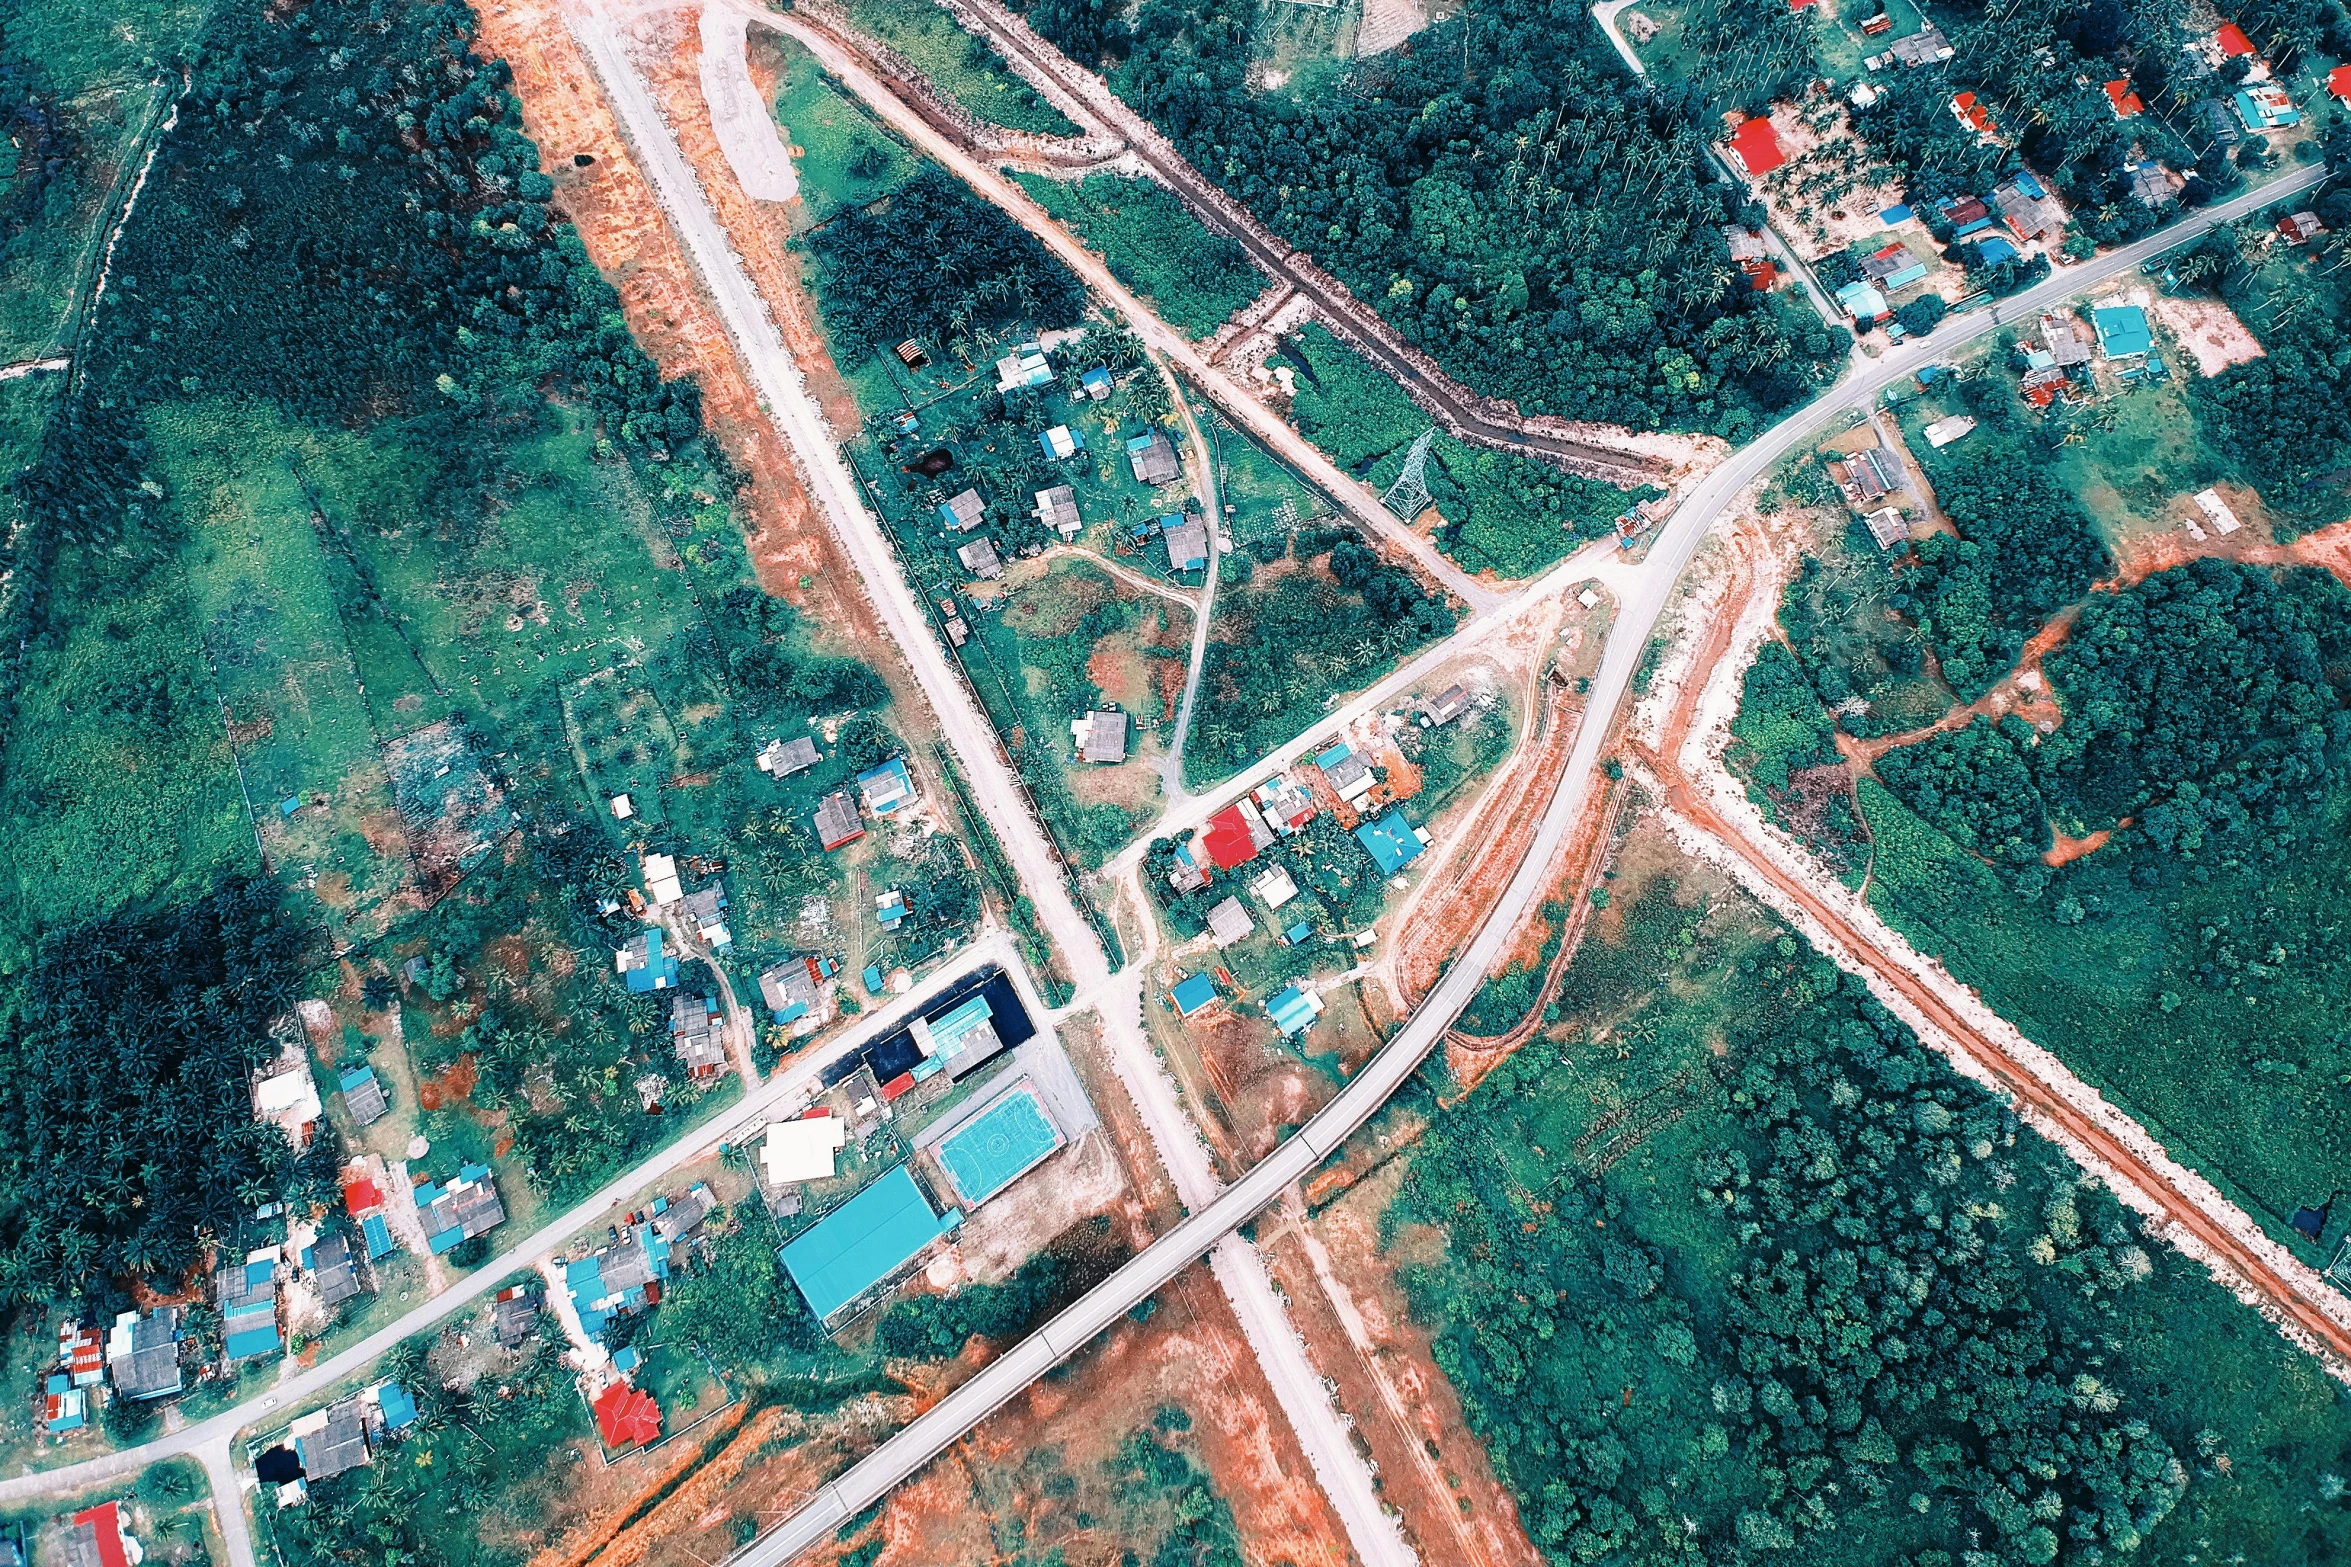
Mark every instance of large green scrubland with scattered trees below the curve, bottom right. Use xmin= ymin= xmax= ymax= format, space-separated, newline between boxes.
xmin=1385 ymin=855 xmax=2351 ymax=1565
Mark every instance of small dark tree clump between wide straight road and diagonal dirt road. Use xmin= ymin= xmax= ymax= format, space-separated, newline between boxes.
xmin=809 ymin=164 xmax=1086 ymax=352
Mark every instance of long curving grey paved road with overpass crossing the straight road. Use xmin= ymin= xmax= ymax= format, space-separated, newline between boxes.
xmin=726 ymin=167 xmax=2325 ymax=1567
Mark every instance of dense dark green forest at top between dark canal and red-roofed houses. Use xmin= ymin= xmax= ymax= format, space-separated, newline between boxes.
xmin=1104 ymin=0 xmax=1843 ymax=439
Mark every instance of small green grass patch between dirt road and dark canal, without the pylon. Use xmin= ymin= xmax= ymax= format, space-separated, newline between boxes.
xmin=1016 ymin=174 xmax=1265 ymax=338
